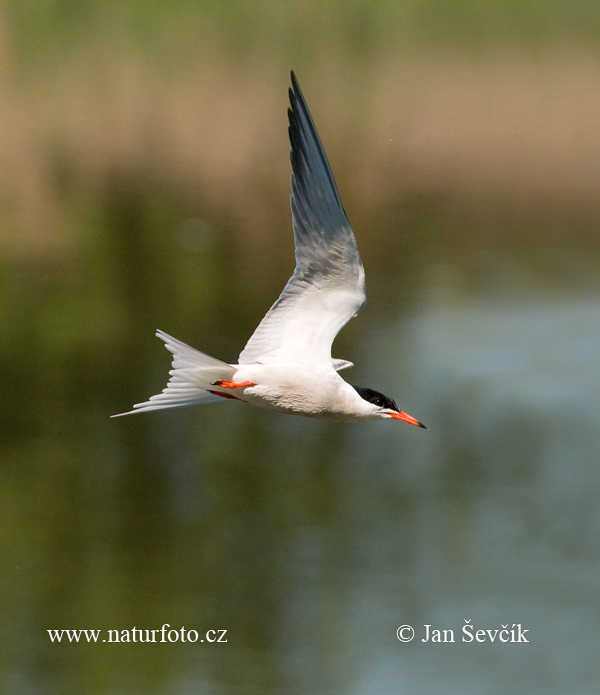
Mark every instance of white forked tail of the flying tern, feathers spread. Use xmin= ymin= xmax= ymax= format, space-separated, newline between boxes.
xmin=111 ymin=331 xmax=235 ymax=417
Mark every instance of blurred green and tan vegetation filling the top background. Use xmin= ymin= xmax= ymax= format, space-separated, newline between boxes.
xmin=0 ymin=0 xmax=600 ymax=264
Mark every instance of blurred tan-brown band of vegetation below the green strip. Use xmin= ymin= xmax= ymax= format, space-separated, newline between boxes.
xmin=0 ymin=12 xmax=600 ymax=262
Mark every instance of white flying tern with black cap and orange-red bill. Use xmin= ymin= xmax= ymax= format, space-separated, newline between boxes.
xmin=113 ymin=72 xmax=427 ymax=429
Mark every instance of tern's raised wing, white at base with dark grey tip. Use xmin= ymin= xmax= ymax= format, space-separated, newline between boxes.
xmin=239 ymin=72 xmax=366 ymax=369
